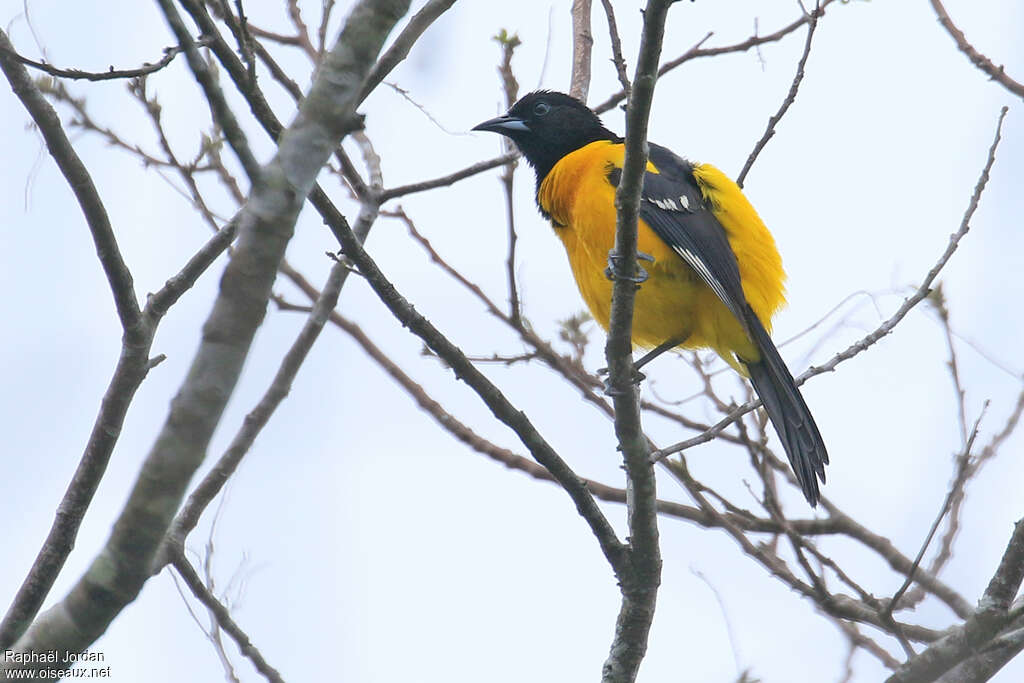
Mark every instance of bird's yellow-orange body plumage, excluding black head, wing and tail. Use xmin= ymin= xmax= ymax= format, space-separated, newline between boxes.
xmin=538 ymin=141 xmax=784 ymax=366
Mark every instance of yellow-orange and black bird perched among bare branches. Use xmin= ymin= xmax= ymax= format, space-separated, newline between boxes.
xmin=473 ymin=90 xmax=828 ymax=507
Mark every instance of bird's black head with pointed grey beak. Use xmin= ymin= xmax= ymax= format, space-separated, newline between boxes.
xmin=473 ymin=90 xmax=622 ymax=184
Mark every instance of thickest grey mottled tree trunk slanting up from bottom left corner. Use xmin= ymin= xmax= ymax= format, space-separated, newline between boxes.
xmin=0 ymin=0 xmax=409 ymax=671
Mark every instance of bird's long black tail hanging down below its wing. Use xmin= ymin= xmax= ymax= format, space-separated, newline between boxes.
xmin=743 ymin=306 xmax=828 ymax=507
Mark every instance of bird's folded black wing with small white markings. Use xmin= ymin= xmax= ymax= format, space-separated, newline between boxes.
xmin=608 ymin=144 xmax=752 ymax=335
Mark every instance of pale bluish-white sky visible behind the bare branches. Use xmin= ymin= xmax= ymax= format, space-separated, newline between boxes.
xmin=0 ymin=0 xmax=1024 ymax=683
